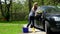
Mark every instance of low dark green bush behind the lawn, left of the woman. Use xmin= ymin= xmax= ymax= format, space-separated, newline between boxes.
xmin=11 ymin=12 xmax=28 ymax=21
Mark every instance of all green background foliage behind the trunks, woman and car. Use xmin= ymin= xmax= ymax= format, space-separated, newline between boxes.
xmin=0 ymin=0 xmax=60 ymax=20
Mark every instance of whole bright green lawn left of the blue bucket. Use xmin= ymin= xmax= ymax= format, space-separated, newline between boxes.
xmin=0 ymin=21 xmax=27 ymax=34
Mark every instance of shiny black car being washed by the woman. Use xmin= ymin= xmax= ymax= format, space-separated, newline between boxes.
xmin=35 ymin=6 xmax=60 ymax=34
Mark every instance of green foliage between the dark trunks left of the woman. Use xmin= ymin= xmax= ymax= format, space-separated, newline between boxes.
xmin=12 ymin=2 xmax=29 ymax=20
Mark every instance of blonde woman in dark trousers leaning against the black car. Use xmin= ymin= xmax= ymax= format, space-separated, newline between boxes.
xmin=27 ymin=2 xmax=37 ymax=28
